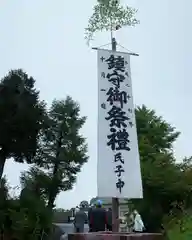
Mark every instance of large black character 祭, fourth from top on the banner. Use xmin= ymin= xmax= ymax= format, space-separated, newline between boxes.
xmin=105 ymin=106 xmax=130 ymax=128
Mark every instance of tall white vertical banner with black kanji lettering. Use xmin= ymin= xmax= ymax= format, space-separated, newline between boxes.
xmin=97 ymin=49 xmax=143 ymax=199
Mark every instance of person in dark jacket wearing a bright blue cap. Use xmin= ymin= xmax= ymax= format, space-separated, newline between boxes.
xmin=90 ymin=200 xmax=107 ymax=232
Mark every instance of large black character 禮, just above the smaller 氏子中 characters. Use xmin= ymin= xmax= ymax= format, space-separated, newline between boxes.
xmin=107 ymin=128 xmax=131 ymax=151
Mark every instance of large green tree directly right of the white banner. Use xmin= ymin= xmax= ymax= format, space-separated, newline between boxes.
xmin=133 ymin=106 xmax=190 ymax=231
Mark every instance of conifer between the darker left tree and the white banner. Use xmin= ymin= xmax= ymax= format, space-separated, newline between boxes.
xmin=22 ymin=97 xmax=88 ymax=208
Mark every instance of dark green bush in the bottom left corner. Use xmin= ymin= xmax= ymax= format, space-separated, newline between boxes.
xmin=0 ymin=182 xmax=52 ymax=240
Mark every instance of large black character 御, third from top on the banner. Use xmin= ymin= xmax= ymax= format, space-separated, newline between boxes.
xmin=107 ymin=87 xmax=128 ymax=108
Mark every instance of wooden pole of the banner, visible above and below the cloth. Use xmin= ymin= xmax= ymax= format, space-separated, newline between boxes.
xmin=111 ymin=37 xmax=119 ymax=232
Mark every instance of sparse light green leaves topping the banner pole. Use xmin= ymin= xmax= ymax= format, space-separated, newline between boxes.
xmin=85 ymin=0 xmax=139 ymax=43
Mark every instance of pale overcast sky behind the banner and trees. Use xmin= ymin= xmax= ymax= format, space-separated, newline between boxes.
xmin=0 ymin=0 xmax=192 ymax=208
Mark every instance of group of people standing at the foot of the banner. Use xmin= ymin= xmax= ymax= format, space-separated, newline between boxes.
xmin=74 ymin=200 xmax=144 ymax=233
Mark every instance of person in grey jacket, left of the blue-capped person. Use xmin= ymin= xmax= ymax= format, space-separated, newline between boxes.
xmin=74 ymin=205 xmax=87 ymax=233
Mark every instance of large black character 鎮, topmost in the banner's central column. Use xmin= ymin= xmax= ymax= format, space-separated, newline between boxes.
xmin=105 ymin=55 xmax=125 ymax=72
